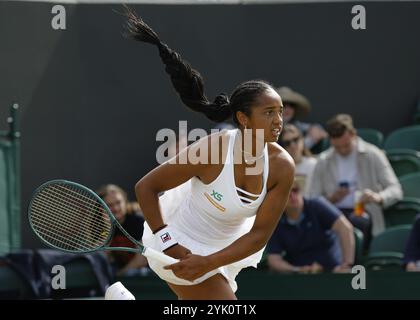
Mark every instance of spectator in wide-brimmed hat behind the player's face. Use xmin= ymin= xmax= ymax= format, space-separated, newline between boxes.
xmin=277 ymin=87 xmax=328 ymax=150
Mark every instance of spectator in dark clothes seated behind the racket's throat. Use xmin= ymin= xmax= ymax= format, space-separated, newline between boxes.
xmin=97 ymin=184 xmax=147 ymax=276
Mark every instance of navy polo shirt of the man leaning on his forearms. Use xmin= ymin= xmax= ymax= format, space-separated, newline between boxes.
xmin=267 ymin=197 xmax=342 ymax=270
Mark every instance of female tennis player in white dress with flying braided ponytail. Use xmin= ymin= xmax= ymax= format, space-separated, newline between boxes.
xmin=127 ymin=9 xmax=294 ymax=300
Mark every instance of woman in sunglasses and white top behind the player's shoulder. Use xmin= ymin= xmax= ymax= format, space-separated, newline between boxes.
xmin=279 ymin=123 xmax=316 ymax=196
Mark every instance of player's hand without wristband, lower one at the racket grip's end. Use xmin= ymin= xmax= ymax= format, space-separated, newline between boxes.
xmin=164 ymin=253 xmax=211 ymax=281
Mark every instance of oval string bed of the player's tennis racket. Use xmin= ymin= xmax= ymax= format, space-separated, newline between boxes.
xmin=31 ymin=186 xmax=112 ymax=251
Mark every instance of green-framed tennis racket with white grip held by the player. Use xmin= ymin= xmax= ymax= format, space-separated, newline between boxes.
xmin=28 ymin=180 xmax=178 ymax=265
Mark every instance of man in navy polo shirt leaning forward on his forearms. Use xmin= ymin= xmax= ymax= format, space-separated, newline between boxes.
xmin=267 ymin=179 xmax=355 ymax=273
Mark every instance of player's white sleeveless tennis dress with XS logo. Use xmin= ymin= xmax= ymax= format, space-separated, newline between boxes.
xmin=143 ymin=129 xmax=269 ymax=292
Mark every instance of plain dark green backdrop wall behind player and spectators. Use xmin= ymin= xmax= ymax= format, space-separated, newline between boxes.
xmin=0 ymin=1 xmax=420 ymax=246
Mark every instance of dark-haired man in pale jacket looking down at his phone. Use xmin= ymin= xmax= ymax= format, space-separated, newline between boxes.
xmin=309 ymin=114 xmax=402 ymax=251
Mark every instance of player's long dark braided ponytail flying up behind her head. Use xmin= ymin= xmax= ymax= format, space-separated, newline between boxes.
xmin=125 ymin=6 xmax=272 ymax=124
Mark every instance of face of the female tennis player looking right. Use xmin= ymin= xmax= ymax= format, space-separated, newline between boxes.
xmin=247 ymin=89 xmax=283 ymax=142
